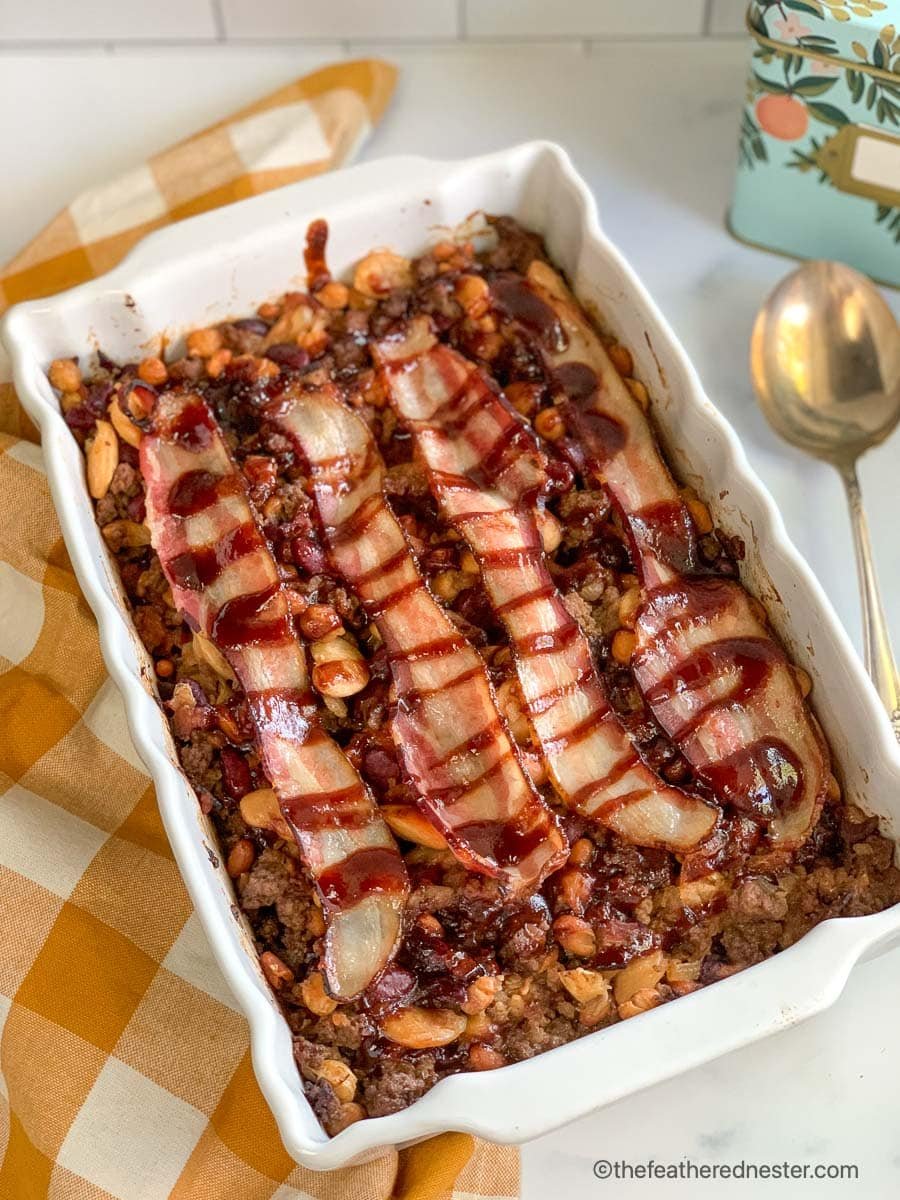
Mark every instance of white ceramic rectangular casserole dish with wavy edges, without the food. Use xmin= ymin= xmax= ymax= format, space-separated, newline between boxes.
xmin=2 ymin=143 xmax=900 ymax=1170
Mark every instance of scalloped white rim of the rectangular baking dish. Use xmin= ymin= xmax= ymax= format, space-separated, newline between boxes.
xmin=7 ymin=142 xmax=900 ymax=1170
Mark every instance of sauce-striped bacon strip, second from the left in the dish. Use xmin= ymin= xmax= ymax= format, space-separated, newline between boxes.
xmin=266 ymin=386 xmax=568 ymax=893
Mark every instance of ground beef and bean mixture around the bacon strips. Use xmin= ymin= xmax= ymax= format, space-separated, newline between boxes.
xmin=56 ymin=218 xmax=900 ymax=1133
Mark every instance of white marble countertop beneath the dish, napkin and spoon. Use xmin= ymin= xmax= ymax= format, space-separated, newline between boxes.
xmin=0 ymin=41 xmax=900 ymax=1200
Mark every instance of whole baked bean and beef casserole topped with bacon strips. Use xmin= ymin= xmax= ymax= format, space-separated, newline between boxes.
xmin=49 ymin=217 xmax=900 ymax=1133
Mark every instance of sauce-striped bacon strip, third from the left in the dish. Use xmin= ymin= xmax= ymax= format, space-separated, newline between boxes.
xmin=376 ymin=325 xmax=716 ymax=851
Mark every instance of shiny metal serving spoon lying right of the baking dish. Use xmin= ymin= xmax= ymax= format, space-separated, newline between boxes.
xmin=750 ymin=262 xmax=900 ymax=739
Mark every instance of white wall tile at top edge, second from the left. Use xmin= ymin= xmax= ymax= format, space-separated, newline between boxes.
xmin=221 ymin=0 xmax=458 ymax=41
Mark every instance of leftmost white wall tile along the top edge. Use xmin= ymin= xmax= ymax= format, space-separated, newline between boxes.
xmin=0 ymin=0 xmax=216 ymax=42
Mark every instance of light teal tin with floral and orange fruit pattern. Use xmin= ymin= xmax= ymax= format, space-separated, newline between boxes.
xmin=730 ymin=0 xmax=900 ymax=284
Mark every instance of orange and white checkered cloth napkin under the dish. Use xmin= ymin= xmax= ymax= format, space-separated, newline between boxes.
xmin=0 ymin=62 xmax=518 ymax=1200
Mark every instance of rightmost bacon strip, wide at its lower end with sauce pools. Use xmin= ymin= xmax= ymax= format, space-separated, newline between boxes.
xmin=494 ymin=263 xmax=830 ymax=848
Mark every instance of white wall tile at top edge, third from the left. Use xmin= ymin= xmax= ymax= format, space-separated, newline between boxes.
xmin=463 ymin=0 xmax=706 ymax=38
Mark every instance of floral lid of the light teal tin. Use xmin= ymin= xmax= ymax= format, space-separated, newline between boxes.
xmin=746 ymin=0 xmax=900 ymax=72
